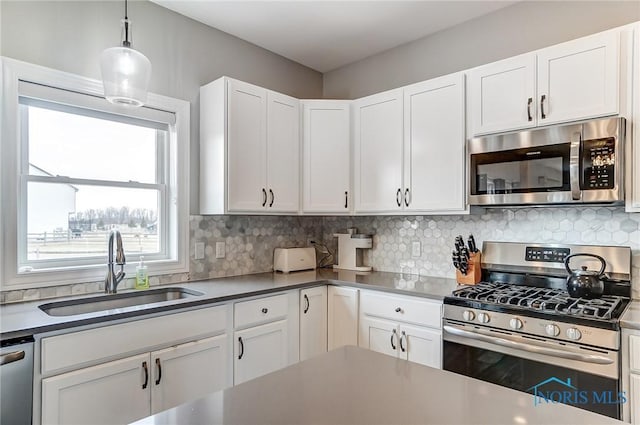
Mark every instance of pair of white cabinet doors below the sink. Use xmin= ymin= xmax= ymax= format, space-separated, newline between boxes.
xmin=42 ymin=335 xmax=228 ymax=425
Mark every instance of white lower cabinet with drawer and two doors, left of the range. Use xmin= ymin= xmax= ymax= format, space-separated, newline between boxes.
xmin=359 ymin=291 xmax=442 ymax=369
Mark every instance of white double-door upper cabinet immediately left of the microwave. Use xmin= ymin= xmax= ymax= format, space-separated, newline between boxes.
xmin=354 ymin=73 xmax=466 ymax=214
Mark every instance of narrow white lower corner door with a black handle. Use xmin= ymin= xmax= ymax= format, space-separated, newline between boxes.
xmin=300 ymin=286 xmax=327 ymax=361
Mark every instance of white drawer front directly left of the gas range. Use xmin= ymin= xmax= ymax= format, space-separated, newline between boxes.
xmin=360 ymin=291 xmax=442 ymax=329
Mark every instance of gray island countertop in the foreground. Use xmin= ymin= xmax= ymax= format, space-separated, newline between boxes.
xmin=135 ymin=347 xmax=623 ymax=425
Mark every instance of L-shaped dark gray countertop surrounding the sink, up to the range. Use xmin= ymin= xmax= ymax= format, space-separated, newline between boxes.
xmin=0 ymin=269 xmax=457 ymax=341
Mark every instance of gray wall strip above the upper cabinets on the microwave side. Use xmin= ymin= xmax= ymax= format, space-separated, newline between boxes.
xmin=323 ymin=0 xmax=640 ymax=99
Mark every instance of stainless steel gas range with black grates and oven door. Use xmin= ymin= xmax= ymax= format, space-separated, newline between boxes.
xmin=443 ymin=242 xmax=631 ymax=419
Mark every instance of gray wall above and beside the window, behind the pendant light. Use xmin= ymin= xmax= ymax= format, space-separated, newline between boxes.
xmin=0 ymin=0 xmax=322 ymax=212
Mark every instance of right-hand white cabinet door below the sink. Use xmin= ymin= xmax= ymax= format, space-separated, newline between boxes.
xmin=150 ymin=335 xmax=231 ymax=414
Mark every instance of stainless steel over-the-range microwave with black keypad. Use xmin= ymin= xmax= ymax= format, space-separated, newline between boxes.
xmin=467 ymin=118 xmax=625 ymax=206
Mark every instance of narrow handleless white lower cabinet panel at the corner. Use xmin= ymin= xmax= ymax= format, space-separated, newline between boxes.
xmin=327 ymin=286 xmax=358 ymax=350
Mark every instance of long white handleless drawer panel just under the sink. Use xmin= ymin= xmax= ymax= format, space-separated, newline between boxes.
xmin=42 ymin=306 xmax=228 ymax=375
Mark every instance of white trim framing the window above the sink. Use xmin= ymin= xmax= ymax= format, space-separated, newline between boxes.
xmin=0 ymin=57 xmax=190 ymax=291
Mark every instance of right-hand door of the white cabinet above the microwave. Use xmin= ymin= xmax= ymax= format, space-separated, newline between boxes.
xmin=537 ymin=32 xmax=619 ymax=125
